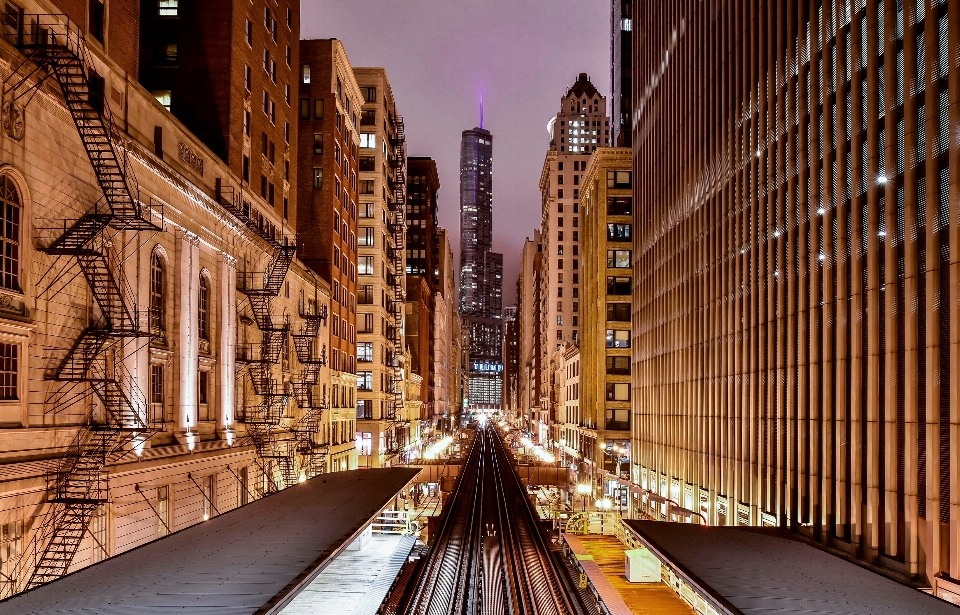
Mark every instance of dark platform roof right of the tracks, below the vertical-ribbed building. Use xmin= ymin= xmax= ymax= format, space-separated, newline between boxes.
xmin=626 ymin=520 xmax=960 ymax=615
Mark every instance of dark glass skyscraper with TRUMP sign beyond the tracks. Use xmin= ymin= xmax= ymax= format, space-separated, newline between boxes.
xmin=460 ymin=128 xmax=503 ymax=410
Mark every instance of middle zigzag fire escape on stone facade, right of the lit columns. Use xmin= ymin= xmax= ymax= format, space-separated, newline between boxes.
xmin=216 ymin=179 xmax=298 ymax=492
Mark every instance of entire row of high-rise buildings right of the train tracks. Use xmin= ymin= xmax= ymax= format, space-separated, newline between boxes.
xmin=505 ymin=0 xmax=960 ymax=601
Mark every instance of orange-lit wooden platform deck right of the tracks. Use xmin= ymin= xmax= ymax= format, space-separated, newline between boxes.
xmin=576 ymin=535 xmax=693 ymax=615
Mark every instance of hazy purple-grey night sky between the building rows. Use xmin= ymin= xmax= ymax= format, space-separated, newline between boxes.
xmin=300 ymin=0 xmax=610 ymax=305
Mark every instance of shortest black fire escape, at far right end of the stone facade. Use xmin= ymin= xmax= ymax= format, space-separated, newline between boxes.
xmin=290 ymin=302 xmax=330 ymax=478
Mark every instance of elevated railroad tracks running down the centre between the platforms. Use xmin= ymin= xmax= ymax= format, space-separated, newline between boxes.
xmin=403 ymin=427 xmax=583 ymax=615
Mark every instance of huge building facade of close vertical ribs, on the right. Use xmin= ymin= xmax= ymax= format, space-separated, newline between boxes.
xmin=631 ymin=0 xmax=960 ymax=592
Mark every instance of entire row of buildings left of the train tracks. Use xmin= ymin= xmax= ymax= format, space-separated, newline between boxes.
xmin=0 ymin=0 xmax=464 ymax=598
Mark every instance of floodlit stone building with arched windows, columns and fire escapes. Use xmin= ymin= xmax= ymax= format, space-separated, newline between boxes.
xmin=0 ymin=2 xmax=342 ymax=596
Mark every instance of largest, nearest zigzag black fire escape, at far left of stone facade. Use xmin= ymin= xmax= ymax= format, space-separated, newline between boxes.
xmin=4 ymin=11 xmax=163 ymax=593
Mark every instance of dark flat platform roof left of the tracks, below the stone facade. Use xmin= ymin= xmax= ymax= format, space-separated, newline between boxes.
xmin=0 ymin=468 xmax=419 ymax=615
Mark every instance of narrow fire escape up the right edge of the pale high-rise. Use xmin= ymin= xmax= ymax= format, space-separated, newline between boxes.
xmin=386 ymin=114 xmax=407 ymax=458
